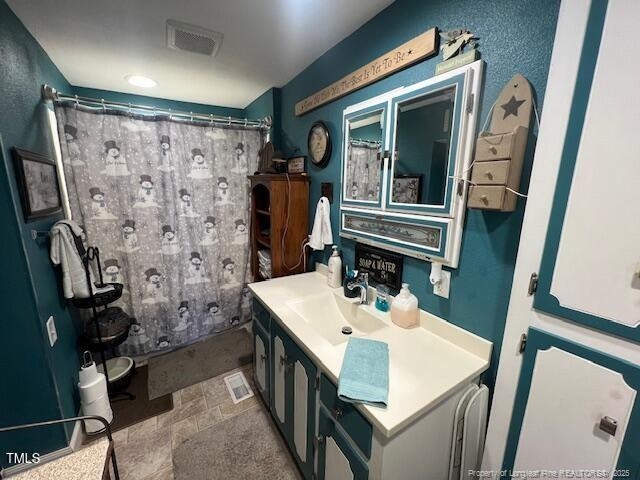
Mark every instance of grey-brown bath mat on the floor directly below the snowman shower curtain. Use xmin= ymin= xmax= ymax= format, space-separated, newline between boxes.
xmin=149 ymin=328 xmax=252 ymax=398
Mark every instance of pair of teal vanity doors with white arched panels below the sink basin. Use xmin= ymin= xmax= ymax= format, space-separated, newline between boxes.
xmin=271 ymin=321 xmax=317 ymax=478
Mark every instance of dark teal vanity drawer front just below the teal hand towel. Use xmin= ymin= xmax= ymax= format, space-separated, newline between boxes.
xmin=320 ymin=375 xmax=373 ymax=458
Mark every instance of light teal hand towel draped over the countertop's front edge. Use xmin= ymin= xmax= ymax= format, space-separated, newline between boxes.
xmin=338 ymin=338 xmax=389 ymax=407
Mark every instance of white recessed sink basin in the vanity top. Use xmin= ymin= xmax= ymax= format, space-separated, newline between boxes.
xmin=287 ymin=292 xmax=386 ymax=345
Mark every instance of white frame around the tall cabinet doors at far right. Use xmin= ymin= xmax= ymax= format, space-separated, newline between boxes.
xmin=482 ymin=0 xmax=640 ymax=472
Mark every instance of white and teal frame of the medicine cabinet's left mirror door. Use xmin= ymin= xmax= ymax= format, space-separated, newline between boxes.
xmin=340 ymin=100 xmax=389 ymax=208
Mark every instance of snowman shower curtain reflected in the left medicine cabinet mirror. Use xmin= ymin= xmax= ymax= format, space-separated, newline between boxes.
xmin=346 ymin=140 xmax=381 ymax=200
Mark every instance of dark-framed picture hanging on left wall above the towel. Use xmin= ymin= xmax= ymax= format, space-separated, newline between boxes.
xmin=13 ymin=148 xmax=62 ymax=222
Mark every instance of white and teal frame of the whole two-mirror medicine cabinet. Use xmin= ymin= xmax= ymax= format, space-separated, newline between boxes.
xmin=340 ymin=60 xmax=484 ymax=268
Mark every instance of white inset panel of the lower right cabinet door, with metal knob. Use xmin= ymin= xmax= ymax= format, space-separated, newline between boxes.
xmin=513 ymin=347 xmax=636 ymax=472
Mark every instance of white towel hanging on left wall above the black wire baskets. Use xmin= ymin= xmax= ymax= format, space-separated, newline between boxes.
xmin=49 ymin=220 xmax=94 ymax=298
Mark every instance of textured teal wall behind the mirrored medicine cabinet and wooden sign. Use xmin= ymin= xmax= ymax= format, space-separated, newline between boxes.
xmin=282 ymin=0 xmax=559 ymax=386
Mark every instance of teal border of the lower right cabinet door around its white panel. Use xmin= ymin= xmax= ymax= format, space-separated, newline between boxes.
xmin=502 ymin=328 xmax=640 ymax=472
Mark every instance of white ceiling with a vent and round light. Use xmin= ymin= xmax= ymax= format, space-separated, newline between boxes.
xmin=7 ymin=0 xmax=392 ymax=108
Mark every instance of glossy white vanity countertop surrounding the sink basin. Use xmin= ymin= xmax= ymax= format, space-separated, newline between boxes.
xmin=249 ymin=266 xmax=492 ymax=437
